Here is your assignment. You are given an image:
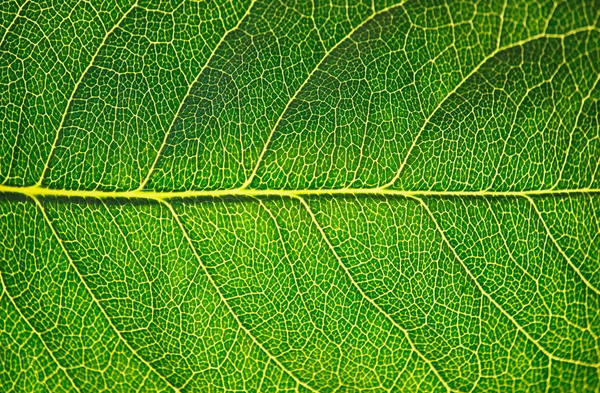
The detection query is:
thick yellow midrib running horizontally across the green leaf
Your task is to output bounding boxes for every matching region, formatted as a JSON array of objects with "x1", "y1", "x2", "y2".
[{"x1": 0, "y1": 185, "x2": 600, "y2": 200}]
